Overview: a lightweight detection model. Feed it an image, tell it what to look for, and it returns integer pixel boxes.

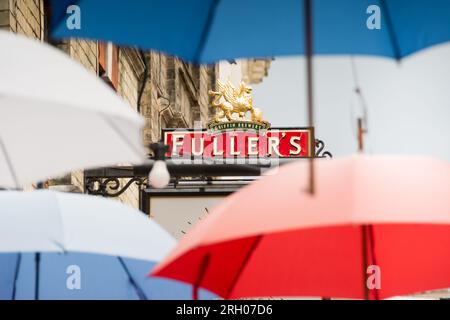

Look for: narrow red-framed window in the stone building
[98,42,119,90]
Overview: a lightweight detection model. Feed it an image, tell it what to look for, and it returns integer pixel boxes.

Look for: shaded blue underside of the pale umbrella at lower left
[0,252,214,300]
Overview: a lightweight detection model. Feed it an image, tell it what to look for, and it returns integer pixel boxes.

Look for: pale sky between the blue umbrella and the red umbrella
[253,45,450,161]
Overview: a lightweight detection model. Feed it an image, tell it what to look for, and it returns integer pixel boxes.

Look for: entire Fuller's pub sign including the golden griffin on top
[163,80,315,159]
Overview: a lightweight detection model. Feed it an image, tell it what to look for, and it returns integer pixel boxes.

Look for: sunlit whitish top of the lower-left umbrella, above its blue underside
[0,190,176,261]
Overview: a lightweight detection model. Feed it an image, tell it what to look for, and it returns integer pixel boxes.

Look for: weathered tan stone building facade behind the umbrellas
[0,0,267,207]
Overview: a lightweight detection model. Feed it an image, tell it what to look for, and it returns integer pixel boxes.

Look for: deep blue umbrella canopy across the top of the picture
[48,0,450,63]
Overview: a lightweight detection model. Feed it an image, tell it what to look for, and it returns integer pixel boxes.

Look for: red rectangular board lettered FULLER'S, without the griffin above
[163,126,314,158]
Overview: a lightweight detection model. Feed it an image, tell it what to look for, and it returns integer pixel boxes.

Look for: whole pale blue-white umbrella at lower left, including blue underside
[0,190,211,299]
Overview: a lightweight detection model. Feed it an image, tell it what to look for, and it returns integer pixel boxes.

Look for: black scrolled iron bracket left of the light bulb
[85,177,147,197]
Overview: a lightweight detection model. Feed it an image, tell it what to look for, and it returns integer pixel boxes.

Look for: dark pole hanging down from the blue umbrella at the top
[303,0,315,194]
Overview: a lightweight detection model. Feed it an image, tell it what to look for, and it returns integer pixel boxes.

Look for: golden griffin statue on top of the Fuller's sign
[208,80,270,127]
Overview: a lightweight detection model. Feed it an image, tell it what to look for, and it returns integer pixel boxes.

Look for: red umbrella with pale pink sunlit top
[152,155,450,299]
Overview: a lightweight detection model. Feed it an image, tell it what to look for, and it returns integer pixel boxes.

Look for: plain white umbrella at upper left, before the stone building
[0,31,145,188]
